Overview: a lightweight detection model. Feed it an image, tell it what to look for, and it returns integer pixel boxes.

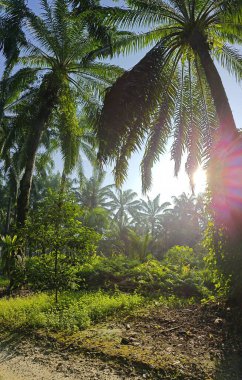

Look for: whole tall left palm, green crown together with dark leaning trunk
[0,0,121,225]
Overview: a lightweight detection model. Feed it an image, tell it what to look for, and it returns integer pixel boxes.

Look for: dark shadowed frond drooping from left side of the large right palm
[97,44,176,161]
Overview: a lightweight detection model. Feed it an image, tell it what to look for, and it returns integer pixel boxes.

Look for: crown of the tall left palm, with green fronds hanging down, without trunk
[12,0,122,171]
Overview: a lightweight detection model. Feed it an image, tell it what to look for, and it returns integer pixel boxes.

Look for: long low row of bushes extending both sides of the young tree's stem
[22,246,214,299]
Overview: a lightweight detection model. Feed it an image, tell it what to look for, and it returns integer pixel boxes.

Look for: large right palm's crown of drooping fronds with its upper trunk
[97,0,242,235]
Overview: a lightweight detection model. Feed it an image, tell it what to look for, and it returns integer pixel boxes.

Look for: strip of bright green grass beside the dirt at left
[0,291,144,331]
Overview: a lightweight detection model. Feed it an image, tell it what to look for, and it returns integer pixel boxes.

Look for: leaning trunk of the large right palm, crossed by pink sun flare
[195,36,242,305]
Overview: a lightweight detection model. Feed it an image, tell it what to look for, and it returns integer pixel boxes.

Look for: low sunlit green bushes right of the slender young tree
[73,246,214,298]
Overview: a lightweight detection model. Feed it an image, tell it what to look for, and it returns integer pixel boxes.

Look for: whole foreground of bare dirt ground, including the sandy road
[0,305,242,380]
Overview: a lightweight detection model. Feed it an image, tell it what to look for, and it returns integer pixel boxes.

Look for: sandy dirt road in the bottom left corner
[0,336,146,380]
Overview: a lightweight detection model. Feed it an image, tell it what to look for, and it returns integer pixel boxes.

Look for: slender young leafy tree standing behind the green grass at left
[21,191,100,301]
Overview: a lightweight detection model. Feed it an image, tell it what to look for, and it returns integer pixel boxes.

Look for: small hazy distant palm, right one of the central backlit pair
[139,194,170,238]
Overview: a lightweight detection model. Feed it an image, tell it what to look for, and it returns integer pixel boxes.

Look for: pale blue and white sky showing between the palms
[4,0,242,202]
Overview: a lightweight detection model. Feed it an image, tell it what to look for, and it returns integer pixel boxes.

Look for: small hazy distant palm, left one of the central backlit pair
[106,189,140,231]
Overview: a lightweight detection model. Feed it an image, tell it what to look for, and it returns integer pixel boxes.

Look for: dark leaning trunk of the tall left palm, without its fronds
[17,75,59,227]
